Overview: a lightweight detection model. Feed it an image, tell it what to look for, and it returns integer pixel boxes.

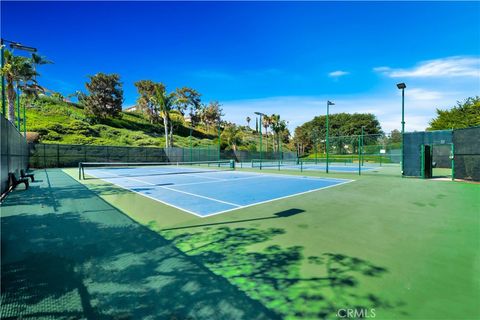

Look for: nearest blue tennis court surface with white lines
[85,168,353,217]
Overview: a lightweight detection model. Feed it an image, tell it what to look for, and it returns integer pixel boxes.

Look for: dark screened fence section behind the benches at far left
[0,115,28,194]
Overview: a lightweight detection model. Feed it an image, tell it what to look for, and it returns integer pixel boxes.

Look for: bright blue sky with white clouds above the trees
[1,1,480,132]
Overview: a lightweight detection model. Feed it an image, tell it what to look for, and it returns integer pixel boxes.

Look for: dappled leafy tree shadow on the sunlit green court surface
[162,226,403,319]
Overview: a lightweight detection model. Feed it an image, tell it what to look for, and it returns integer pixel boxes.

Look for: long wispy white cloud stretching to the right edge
[373,56,480,78]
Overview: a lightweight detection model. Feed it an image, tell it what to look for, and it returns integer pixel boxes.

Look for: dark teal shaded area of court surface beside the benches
[0,169,277,320]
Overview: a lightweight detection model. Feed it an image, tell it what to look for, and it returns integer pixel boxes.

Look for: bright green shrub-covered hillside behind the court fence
[23,97,216,147]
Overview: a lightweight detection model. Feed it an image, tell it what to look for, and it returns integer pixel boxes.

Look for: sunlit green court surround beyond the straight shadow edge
[66,169,480,319]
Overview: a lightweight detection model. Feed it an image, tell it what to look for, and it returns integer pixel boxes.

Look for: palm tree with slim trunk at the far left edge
[1,50,39,123]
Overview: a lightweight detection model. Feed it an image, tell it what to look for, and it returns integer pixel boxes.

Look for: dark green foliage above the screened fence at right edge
[427,96,480,130]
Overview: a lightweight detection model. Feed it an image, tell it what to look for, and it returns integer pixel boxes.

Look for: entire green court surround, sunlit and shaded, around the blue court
[1,169,480,319]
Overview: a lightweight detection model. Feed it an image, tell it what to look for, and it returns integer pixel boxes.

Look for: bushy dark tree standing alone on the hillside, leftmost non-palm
[82,73,123,121]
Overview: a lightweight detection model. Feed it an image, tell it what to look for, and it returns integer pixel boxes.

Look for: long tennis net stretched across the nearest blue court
[78,160,235,180]
